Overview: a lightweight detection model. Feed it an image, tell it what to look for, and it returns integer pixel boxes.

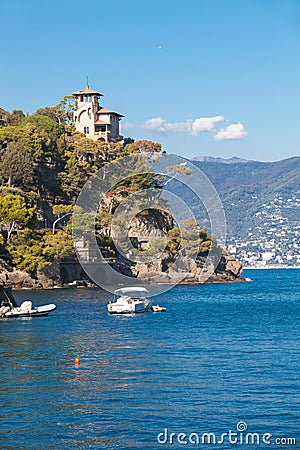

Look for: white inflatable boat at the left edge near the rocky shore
[0,285,56,318]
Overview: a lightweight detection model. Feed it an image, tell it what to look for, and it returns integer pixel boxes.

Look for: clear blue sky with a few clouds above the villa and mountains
[0,0,300,161]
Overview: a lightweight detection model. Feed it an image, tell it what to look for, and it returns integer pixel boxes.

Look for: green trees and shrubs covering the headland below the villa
[0,97,240,284]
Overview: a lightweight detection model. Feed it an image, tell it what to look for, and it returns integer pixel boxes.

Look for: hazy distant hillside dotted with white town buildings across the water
[193,157,300,265]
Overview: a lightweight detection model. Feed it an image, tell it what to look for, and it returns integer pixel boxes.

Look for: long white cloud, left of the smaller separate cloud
[142,116,225,136]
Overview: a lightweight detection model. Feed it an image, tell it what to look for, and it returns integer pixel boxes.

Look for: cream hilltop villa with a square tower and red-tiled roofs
[72,84,124,142]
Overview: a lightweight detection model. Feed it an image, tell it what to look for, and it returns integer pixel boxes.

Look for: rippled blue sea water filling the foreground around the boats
[0,269,300,450]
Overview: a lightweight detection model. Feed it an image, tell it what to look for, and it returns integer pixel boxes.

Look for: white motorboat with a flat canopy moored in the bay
[107,287,151,314]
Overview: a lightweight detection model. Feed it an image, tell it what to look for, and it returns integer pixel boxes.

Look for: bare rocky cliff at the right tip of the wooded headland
[97,196,242,283]
